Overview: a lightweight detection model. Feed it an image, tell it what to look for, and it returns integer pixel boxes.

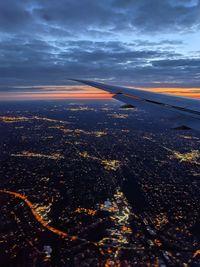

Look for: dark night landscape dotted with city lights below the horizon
[0,100,200,267]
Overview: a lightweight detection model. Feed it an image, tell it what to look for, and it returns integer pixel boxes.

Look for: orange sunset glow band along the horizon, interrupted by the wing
[0,85,200,101]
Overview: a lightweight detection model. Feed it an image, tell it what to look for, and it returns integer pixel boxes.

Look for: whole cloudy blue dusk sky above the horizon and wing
[0,0,200,99]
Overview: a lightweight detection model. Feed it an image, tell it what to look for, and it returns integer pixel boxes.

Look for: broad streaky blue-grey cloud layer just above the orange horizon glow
[0,39,199,87]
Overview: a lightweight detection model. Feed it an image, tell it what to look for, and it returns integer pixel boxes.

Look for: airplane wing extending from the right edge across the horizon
[73,80,200,131]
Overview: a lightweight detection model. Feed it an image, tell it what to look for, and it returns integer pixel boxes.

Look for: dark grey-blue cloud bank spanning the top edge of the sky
[0,0,200,32]
